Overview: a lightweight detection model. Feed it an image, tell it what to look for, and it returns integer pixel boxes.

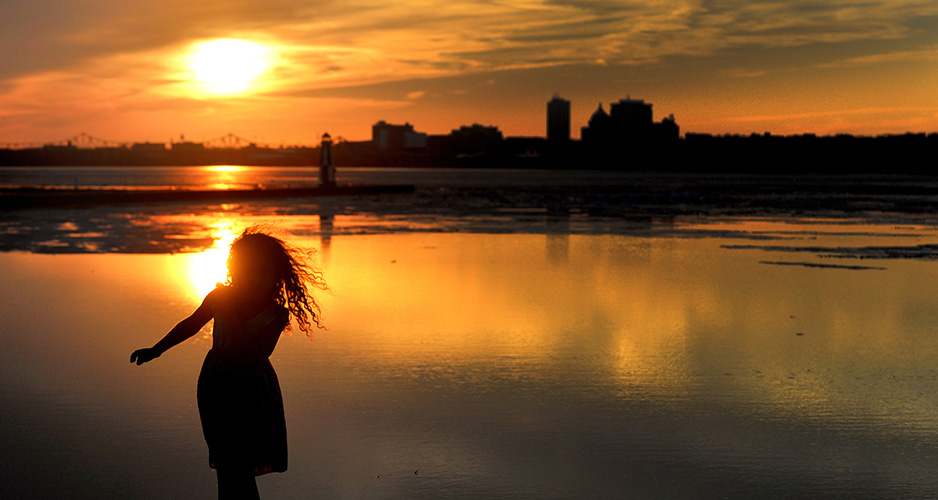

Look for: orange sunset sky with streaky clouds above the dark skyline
[0,0,938,147]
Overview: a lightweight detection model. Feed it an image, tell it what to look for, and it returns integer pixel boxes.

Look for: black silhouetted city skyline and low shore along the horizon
[0,94,938,173]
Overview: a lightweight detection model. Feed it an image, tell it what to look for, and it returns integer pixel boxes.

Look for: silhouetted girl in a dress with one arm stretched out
[130,228,326,500]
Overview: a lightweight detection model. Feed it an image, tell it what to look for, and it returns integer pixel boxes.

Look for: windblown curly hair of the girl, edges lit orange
[227,226,329,338]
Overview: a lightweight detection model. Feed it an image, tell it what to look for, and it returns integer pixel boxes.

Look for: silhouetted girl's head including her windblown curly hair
[228,227,327,334]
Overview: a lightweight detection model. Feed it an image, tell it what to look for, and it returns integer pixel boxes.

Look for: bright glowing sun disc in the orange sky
[189,38,275,95]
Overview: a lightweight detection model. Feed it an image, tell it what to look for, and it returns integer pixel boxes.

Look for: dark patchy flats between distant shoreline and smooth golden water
[0,171,938,259]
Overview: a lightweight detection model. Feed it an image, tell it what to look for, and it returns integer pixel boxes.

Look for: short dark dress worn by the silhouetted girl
[198,294,288,475]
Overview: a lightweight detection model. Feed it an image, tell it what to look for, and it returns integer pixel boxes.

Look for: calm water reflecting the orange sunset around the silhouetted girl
[0,169,938,499]
